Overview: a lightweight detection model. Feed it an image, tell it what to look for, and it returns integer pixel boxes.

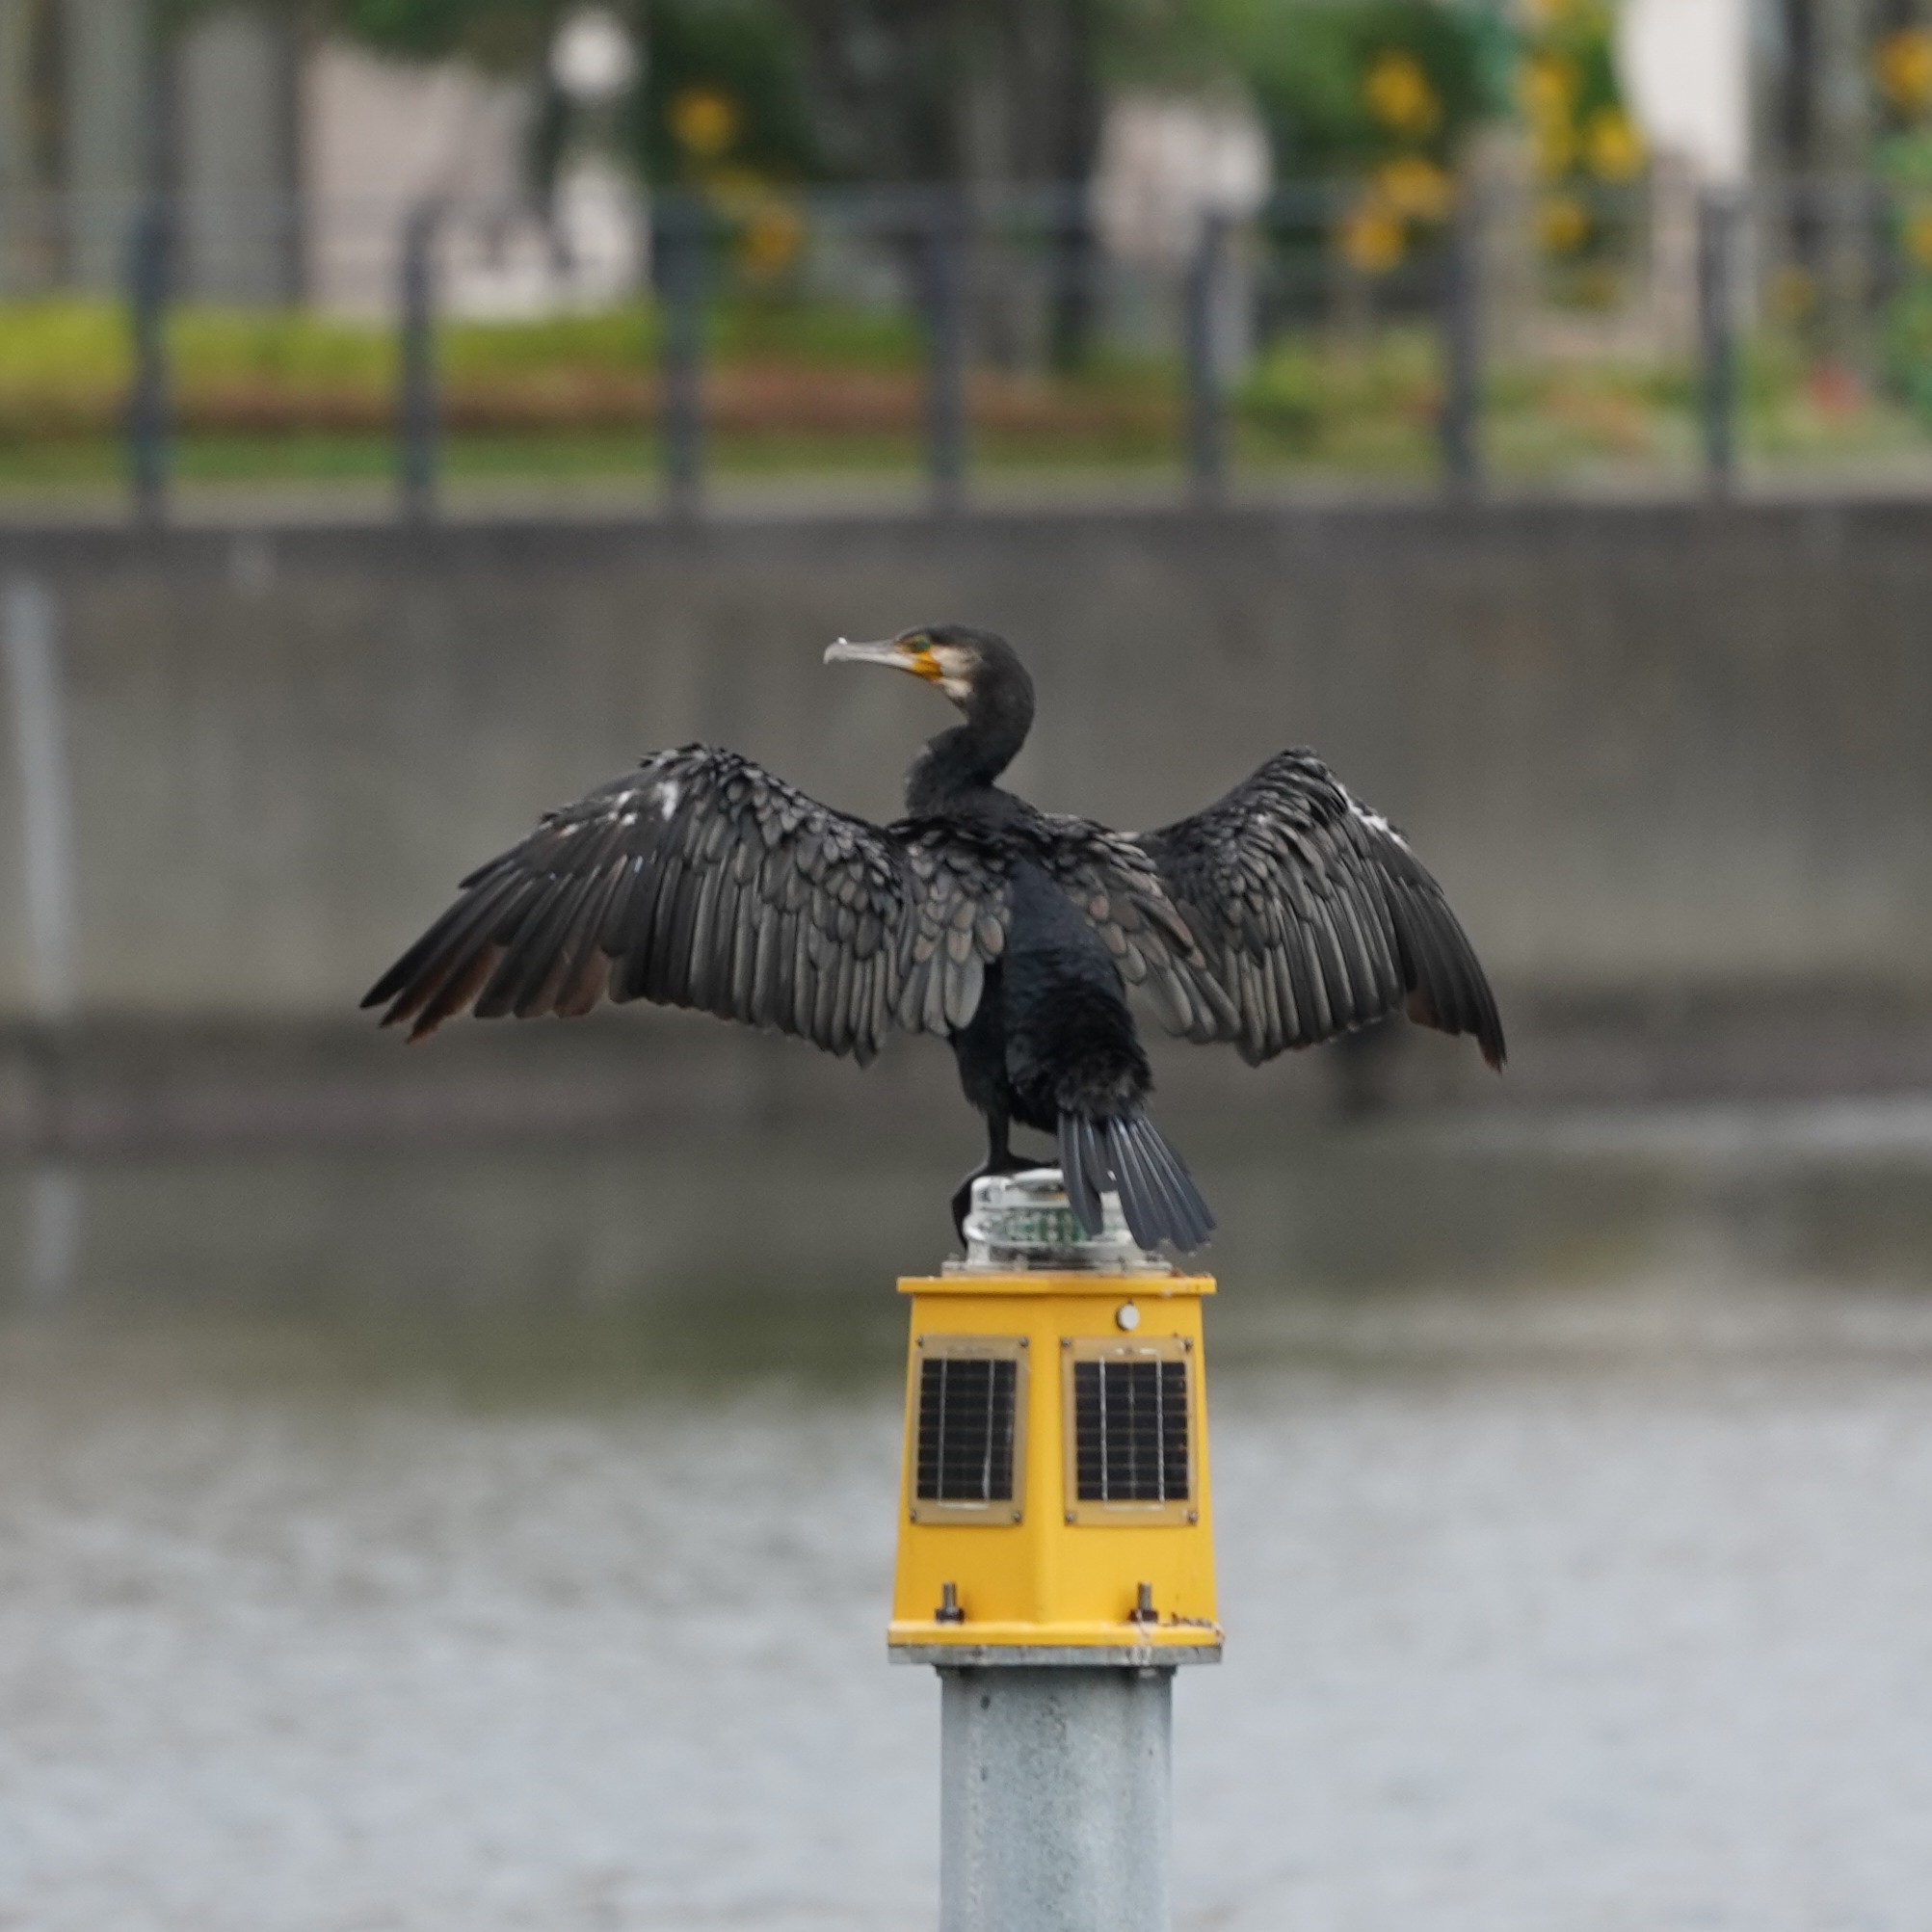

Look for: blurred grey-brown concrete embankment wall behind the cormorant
[0,506,1932,1017]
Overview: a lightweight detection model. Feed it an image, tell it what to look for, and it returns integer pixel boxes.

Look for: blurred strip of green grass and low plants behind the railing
[11,300,1932,498]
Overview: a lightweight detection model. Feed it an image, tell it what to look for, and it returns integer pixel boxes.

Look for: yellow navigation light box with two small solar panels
[887,1267,1221,1663]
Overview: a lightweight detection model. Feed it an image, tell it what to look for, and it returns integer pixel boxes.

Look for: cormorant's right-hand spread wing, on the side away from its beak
[1138,750,1503,1067]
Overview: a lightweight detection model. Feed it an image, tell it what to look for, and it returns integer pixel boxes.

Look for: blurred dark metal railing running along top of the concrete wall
[0,175,1932,521]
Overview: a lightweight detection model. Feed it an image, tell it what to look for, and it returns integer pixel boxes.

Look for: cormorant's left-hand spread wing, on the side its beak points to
[363,746,935,1061]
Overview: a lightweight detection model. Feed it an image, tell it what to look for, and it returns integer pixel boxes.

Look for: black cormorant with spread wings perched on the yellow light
[363,624,1503,1252]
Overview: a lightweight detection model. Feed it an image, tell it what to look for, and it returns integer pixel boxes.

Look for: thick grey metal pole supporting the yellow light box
[939,1663,1175,1932]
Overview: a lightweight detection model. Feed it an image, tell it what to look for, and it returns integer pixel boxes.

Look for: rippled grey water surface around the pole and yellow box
[0,1103,1932,1932]
